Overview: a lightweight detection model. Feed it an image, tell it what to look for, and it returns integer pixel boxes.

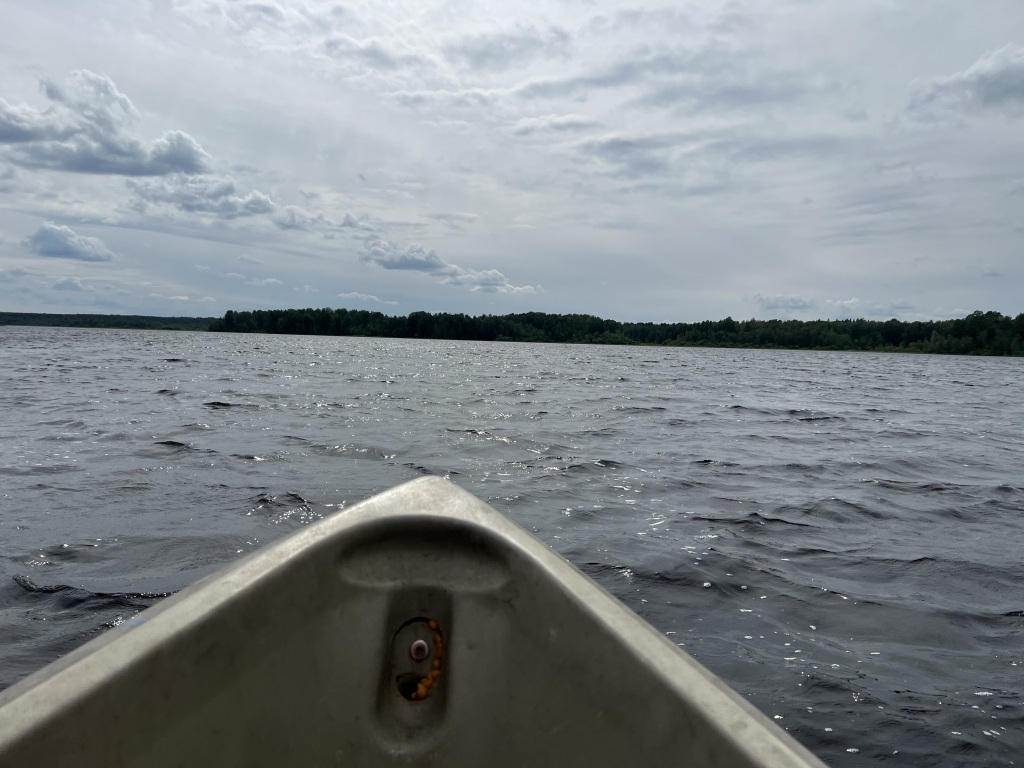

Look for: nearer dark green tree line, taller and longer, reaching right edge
[207,308,1024,355]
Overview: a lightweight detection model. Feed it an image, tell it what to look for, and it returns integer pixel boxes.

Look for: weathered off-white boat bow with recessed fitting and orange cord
[0,478,822,768]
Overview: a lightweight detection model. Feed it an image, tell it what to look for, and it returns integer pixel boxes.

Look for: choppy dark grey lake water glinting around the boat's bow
[0,328,1024,766]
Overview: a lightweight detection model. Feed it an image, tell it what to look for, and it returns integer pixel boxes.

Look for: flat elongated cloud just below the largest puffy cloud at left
[127,174,276,219]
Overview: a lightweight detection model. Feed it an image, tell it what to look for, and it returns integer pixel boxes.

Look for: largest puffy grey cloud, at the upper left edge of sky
[0,70,210,176]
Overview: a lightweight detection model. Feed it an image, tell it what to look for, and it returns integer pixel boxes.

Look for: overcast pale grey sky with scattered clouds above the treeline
[0,0,1024,323]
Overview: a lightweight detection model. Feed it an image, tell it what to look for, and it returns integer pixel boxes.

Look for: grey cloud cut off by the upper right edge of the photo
[908,45,1024,118]
